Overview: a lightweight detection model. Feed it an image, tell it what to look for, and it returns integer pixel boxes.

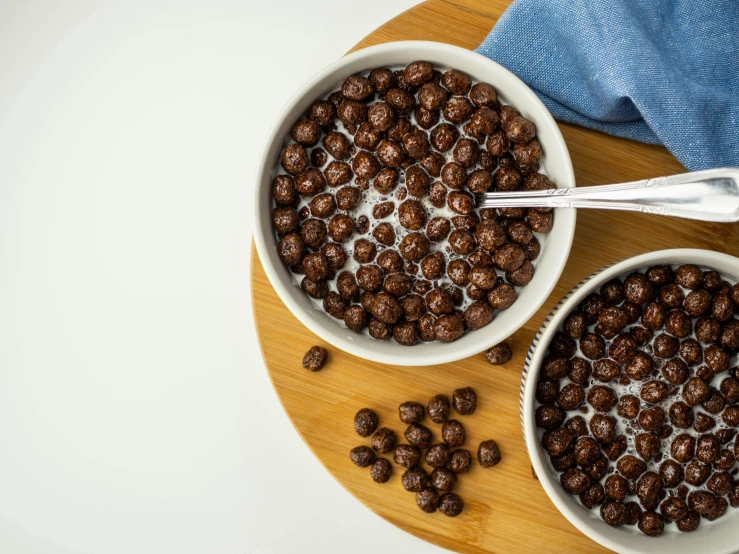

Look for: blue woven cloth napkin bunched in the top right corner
[477,0,739,170]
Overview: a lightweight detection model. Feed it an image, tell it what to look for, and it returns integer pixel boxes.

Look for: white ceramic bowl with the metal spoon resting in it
[254,41,575,366]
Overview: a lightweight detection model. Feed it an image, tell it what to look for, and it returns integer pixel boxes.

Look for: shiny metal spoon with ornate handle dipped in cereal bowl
[475,167,739,223]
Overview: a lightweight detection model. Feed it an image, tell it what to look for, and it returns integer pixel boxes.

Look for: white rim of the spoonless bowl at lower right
[521,248,739,554]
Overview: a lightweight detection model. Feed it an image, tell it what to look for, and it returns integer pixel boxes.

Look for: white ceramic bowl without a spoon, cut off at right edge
[520,249,739,554]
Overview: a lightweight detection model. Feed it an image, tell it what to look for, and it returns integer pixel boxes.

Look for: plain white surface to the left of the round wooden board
[0,0,472,554]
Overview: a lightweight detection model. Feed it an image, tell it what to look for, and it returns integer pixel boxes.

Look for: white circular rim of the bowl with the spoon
[252,40,577,366]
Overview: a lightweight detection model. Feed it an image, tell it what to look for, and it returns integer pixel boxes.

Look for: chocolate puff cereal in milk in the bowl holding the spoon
[271,60,556,342]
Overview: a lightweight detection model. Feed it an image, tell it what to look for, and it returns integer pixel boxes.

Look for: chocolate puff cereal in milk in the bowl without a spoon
[536,264,739,537]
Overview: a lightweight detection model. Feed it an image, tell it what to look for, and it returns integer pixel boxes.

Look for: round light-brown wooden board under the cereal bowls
[252,0,739,553]
